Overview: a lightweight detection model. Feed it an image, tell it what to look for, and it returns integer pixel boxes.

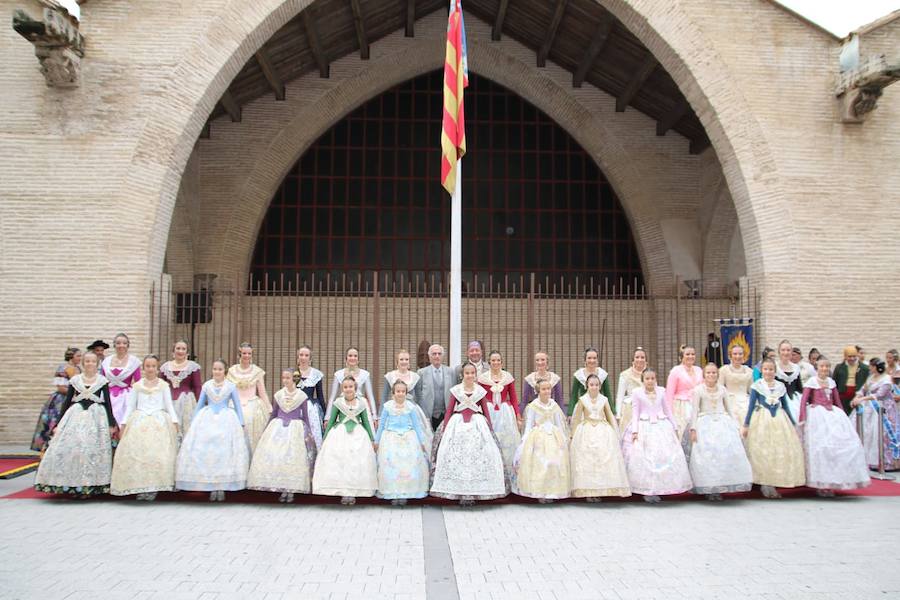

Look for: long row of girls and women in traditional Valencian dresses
[35,334,884,504]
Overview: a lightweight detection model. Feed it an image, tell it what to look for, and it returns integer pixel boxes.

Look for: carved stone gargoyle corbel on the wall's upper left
[13,0,84,87]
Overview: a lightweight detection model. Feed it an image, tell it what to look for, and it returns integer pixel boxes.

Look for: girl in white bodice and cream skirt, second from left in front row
[110,354,178,500]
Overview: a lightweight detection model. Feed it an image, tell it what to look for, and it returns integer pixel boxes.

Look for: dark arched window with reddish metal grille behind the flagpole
[252,72,643,289]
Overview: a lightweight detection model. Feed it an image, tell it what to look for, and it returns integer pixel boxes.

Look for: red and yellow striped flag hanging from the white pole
[441,0,469,196]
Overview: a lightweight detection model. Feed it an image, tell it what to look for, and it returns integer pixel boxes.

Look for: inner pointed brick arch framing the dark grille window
[198,15,697,290]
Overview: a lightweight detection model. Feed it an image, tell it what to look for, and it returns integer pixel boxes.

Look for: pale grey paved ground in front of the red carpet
[0,477,900,600]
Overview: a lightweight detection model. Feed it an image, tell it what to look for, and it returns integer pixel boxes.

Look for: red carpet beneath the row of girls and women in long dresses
[3,474,900,506]
